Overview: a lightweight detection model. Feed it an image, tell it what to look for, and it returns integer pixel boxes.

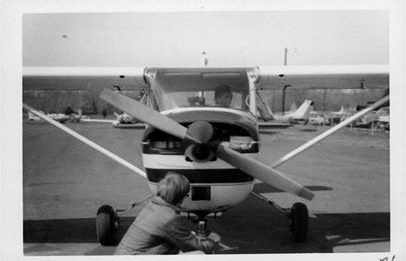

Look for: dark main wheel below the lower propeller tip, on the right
[290,202,309,242]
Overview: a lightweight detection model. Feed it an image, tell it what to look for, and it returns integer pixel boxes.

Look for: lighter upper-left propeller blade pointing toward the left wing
[100,89,201,143]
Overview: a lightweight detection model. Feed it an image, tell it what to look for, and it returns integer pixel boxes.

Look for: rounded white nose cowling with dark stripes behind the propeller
[142,107,259,212]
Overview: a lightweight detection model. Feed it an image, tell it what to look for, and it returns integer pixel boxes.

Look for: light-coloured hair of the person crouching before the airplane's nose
[157,172,190,205]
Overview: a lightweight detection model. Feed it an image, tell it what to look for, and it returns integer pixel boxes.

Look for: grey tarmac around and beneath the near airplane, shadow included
[23,121,391,256]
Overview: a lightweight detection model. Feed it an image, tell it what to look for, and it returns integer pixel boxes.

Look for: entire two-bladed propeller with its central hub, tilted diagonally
[101,89,314,200]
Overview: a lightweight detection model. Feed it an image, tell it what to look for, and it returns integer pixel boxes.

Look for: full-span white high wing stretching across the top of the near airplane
[23,65,389,92]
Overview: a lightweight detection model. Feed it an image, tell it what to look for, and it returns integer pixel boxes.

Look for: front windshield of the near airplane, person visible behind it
[149,69,249,111]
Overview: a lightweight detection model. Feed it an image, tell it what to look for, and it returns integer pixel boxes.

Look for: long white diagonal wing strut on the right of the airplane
[272,95,389,168]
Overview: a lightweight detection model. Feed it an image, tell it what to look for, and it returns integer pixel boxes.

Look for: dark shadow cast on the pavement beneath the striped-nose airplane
[24,197,390,255]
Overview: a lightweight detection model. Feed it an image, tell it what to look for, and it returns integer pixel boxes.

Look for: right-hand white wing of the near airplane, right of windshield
[258,65,389,89]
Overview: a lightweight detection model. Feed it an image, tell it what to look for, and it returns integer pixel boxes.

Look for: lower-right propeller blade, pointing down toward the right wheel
[217,145,314,200]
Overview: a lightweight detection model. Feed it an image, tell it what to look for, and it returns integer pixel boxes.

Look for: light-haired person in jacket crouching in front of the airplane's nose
[116,172,220,255]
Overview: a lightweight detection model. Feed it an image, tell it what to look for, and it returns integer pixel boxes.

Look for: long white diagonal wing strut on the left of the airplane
[23,103,147,178]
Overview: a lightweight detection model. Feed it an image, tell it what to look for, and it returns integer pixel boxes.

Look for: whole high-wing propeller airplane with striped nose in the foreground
[23,65,389,245]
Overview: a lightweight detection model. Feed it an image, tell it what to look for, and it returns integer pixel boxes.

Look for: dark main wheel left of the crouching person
[96,205,118,246]
